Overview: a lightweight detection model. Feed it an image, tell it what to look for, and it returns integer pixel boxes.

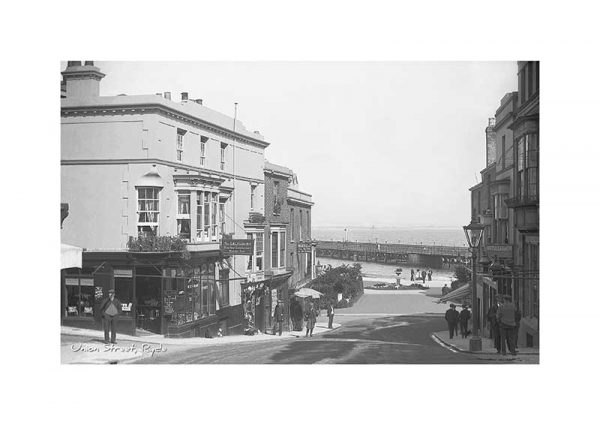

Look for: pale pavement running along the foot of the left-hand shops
[61,317,341,364]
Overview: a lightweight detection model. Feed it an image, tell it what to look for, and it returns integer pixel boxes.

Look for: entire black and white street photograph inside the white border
[60,60,541,364]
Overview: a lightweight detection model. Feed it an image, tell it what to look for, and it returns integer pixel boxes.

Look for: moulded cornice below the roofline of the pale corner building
[60,103,269,148]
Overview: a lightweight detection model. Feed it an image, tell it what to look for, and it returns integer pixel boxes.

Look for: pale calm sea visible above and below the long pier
[312,226,466,288]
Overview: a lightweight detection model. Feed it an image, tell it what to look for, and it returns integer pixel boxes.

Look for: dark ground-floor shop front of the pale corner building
[61,251,241,337]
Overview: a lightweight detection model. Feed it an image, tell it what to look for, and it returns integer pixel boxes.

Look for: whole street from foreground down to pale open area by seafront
[130,288,506,364]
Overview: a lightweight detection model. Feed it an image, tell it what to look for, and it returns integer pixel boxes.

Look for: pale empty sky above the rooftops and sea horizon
[79,61,517,227]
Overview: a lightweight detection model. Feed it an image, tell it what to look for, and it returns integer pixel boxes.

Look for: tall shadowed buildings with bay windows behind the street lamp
[469,62,539,346]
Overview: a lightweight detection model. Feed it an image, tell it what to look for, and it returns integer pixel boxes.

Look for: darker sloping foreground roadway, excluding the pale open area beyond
[138,316,483,364]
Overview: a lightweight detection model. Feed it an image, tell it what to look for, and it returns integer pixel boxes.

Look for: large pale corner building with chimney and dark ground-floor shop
[61,61,268,336]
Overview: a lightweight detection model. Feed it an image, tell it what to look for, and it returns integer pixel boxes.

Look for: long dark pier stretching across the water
[316,241,469,269]
